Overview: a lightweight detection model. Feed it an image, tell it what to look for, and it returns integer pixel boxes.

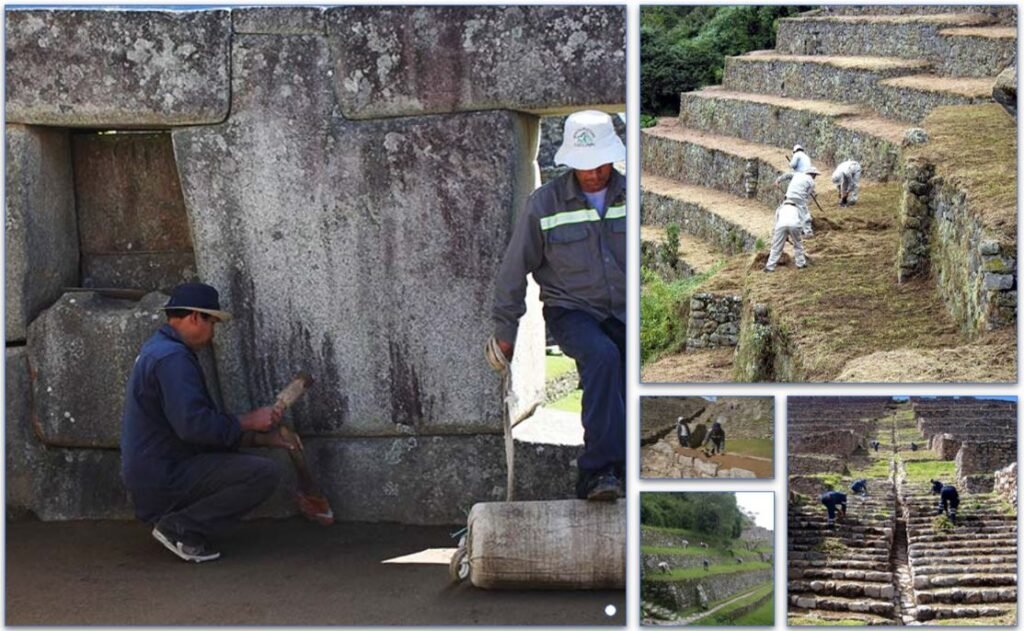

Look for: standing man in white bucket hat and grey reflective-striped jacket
[487,111,626,501]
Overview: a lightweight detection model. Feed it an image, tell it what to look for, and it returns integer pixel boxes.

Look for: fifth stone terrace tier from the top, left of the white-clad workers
[640,173,774,254]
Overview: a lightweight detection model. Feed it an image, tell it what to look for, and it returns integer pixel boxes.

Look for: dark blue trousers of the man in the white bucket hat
[544,307,626,476]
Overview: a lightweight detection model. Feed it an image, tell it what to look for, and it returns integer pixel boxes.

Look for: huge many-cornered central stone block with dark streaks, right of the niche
[174,33,543,435]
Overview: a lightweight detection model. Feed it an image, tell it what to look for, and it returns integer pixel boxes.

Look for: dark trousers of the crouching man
[132,453,282,545]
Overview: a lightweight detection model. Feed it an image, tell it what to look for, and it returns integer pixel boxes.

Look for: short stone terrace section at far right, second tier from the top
[869,74,995,124]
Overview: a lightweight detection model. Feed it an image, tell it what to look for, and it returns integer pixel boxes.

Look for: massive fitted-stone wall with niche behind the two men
[5,6,626,523]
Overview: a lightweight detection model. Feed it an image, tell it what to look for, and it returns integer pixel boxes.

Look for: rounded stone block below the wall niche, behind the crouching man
[29,292,167,448]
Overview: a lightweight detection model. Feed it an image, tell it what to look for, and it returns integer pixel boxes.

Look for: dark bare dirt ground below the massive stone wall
[4,518,626,627]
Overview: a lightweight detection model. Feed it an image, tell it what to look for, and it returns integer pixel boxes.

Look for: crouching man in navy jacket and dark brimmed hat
[121,283,295,562]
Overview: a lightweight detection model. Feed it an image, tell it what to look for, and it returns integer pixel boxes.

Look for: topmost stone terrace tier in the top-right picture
[775,13,1016,77]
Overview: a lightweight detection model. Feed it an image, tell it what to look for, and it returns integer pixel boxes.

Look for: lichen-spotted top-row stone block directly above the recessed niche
[5,9,231,127]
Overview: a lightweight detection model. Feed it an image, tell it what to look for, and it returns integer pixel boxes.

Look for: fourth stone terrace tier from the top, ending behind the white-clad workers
[640,118,802,208]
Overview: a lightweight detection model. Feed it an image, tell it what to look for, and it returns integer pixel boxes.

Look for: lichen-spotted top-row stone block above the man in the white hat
[327,5,626,119]
